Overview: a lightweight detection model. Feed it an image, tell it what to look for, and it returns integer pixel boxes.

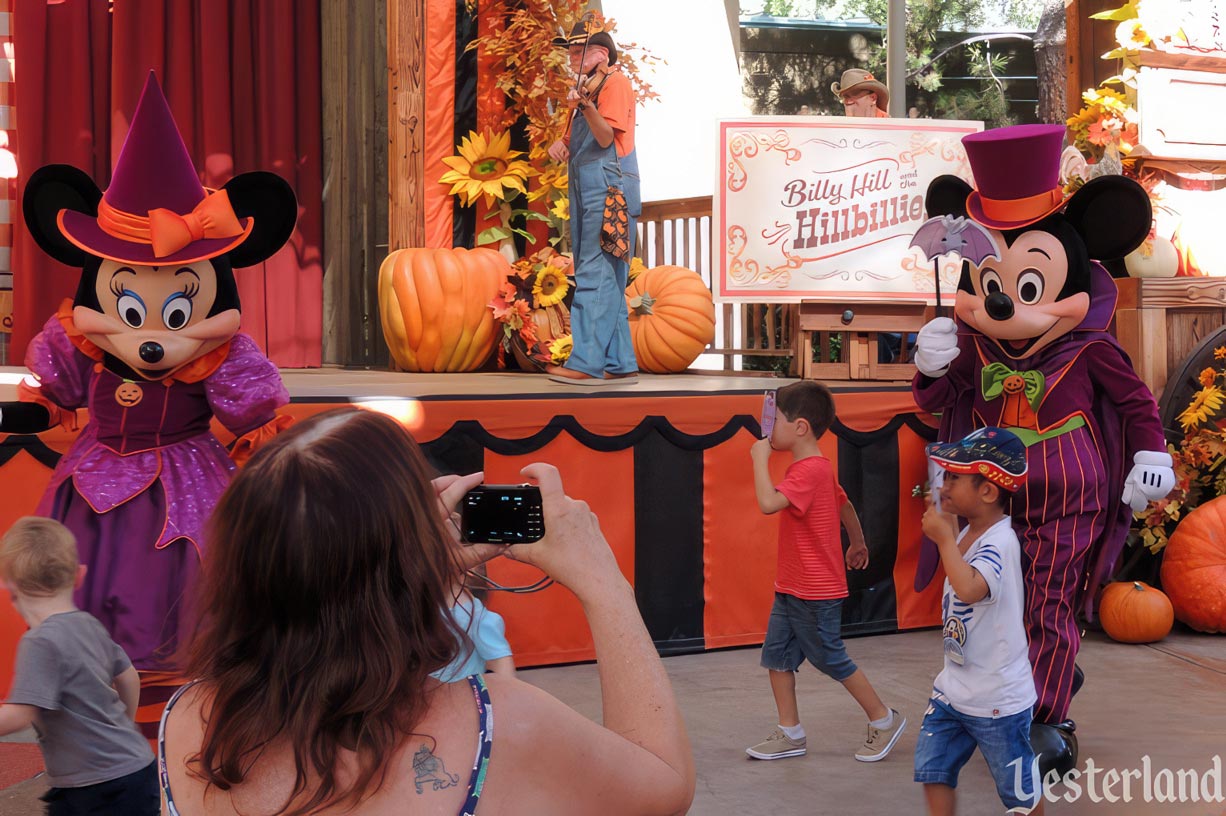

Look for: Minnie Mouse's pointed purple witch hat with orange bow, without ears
[56,71,255,265]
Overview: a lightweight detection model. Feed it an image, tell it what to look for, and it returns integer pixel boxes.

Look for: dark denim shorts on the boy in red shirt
[761,592,856,682]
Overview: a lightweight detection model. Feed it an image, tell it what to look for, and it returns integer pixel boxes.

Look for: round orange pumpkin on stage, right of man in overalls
[625,266,715,374]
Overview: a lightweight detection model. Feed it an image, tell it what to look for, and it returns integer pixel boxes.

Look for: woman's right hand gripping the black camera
[506,462,624,600]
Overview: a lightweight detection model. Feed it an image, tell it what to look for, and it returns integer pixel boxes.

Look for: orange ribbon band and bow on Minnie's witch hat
[98,190,244,257]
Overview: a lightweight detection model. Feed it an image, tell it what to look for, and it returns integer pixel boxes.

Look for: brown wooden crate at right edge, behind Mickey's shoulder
[1114,278,1226,395]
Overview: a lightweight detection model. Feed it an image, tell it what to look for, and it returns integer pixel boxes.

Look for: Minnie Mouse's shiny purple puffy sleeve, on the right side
[205,334,289,436]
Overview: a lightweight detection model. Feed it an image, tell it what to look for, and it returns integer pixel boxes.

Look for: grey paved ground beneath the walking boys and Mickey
[0,631,1226,816]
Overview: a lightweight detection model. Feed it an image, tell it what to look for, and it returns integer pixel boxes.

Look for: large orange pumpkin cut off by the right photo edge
[1162,496,1226,632]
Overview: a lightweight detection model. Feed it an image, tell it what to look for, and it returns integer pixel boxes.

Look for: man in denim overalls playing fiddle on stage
[546,22,642,386]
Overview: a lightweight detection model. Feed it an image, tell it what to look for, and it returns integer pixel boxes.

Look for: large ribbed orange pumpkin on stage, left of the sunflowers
[379,241,511,371]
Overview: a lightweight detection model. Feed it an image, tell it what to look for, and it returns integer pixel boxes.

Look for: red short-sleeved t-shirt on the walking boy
[775,456,847,600]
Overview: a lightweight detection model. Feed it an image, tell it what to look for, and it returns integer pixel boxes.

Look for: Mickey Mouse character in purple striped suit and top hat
[912,125,1175,762]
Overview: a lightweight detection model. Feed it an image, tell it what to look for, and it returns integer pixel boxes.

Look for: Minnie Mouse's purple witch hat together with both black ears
[23,71,298,266]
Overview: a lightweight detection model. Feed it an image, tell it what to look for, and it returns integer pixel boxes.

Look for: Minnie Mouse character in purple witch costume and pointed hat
[0,74,297,670]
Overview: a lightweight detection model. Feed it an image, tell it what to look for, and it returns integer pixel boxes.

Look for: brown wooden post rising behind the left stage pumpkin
[387,0,425,251]
